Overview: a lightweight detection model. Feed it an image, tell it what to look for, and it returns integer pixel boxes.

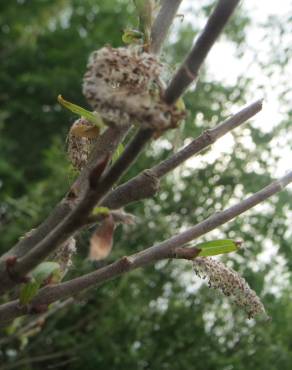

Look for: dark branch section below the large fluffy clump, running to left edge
[0,129,153,293]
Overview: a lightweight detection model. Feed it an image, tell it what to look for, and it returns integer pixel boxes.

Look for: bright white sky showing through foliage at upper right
[179,0,292,176]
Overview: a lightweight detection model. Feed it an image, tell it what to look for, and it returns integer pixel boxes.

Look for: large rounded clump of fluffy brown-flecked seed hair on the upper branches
[83,46,185,131]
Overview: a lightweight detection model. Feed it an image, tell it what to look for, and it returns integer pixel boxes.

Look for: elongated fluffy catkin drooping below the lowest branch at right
[193,257,267,318]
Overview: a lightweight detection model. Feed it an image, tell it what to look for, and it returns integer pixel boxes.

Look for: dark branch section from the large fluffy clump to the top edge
[164,0,240,104]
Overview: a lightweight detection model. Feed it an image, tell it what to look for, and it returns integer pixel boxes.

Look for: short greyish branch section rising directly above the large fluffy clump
[150,0,182,54]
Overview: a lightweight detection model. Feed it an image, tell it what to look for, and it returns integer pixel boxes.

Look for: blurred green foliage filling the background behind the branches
[0,0,292,370]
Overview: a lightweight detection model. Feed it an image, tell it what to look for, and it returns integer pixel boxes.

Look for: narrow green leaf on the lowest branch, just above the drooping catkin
[196,239,240,257]
